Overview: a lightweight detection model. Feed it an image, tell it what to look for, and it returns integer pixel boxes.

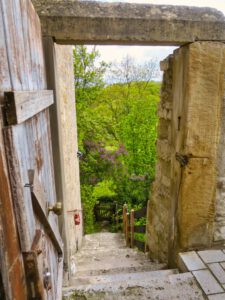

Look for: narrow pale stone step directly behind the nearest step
[70,269,179,289]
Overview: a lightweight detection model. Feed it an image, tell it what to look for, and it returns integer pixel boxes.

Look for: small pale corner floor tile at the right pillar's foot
[179,251,207,271]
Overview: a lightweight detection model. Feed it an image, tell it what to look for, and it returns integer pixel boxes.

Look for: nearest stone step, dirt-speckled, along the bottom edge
[63,273,204,300]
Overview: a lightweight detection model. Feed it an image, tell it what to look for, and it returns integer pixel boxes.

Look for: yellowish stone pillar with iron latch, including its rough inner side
[148,42,225,262]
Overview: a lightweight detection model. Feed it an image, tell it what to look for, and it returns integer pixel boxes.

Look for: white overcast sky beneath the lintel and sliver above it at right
[87,0,225,79]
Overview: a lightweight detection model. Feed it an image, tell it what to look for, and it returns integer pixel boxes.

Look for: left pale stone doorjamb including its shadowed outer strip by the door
[44,38,83,276]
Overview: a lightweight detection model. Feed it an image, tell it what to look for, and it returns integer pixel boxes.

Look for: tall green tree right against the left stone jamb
[73,45,107,232]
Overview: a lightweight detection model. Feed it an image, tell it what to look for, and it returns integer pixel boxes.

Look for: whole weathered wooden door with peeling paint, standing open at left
[0,0,63,300]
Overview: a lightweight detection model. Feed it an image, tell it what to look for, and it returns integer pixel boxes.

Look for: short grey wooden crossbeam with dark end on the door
[4,90,54,125]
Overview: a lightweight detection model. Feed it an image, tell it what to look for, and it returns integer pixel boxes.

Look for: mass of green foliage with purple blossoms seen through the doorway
[74,46,160,232]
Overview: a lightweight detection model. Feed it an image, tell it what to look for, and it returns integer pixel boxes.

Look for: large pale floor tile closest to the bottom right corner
[192,270,224,295]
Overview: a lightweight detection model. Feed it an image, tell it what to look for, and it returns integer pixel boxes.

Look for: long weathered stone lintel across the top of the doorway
[33,0,225,45]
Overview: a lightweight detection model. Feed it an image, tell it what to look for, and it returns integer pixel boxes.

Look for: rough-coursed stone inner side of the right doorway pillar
[147,56,173,261]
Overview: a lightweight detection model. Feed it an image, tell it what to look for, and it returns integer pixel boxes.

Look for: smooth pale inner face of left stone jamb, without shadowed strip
[55,44,83,256]
